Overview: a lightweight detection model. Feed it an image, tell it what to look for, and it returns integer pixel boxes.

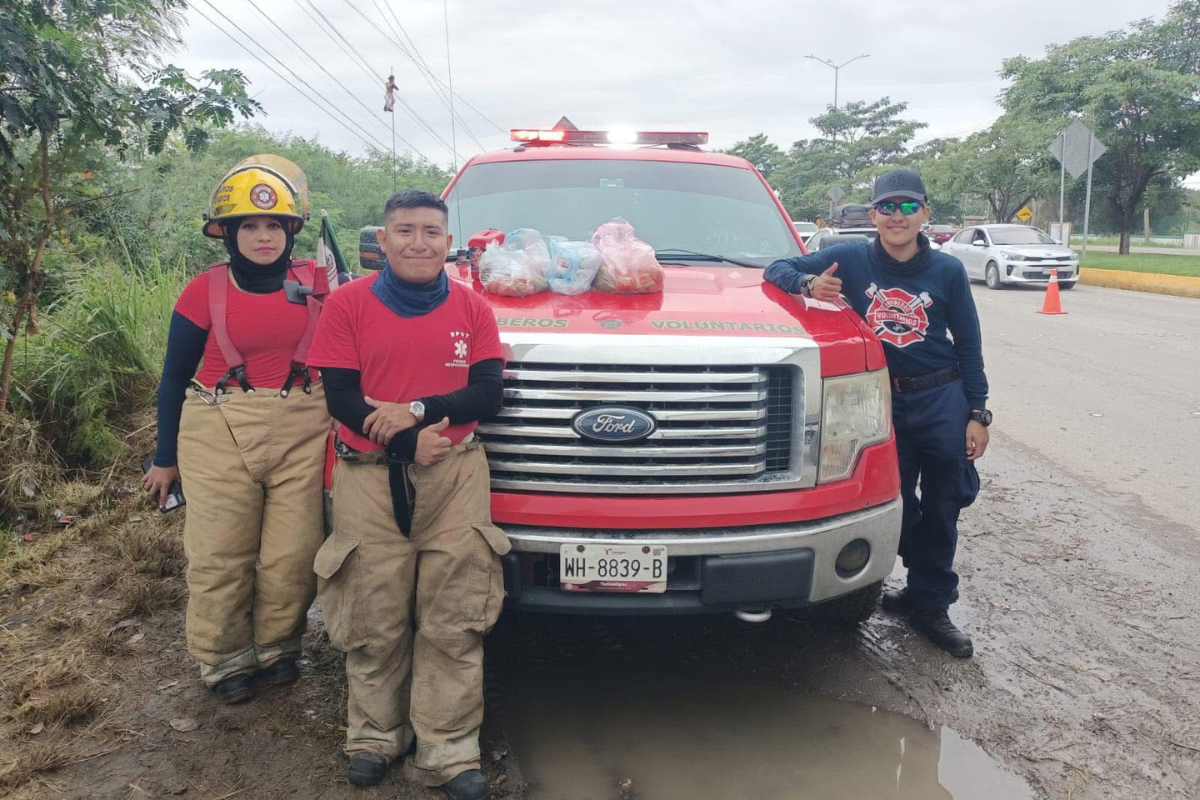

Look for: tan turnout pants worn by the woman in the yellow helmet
[179,384,330,686]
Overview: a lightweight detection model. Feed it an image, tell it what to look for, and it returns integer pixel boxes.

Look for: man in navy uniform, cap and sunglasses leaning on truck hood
[766,169,991,658]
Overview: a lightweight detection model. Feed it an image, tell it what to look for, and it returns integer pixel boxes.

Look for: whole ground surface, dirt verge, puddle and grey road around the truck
[0,287,1200,800]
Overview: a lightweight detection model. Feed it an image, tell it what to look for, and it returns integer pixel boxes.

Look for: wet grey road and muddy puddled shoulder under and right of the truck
[487,287,1200,800]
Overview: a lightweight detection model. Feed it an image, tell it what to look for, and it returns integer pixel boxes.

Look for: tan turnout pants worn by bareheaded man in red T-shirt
[316,441,511,786]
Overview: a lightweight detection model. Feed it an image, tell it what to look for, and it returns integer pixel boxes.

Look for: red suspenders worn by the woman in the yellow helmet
[209,261,329,397]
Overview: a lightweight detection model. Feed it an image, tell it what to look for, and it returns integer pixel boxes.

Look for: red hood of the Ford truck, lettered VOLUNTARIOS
[448,265,877,375]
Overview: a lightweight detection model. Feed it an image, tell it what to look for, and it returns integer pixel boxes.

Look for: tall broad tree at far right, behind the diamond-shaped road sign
[1001,0,1200,254]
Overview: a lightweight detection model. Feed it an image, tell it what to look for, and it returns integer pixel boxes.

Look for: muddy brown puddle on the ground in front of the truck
[505,670,1033,800]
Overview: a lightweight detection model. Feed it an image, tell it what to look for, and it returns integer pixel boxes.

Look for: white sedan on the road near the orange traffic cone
[942,225,1079,289]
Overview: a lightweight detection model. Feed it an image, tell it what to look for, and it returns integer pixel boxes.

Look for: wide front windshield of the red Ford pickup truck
[446,160,800,266]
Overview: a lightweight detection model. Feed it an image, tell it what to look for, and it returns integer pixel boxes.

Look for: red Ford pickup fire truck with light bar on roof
[410,130,901,622]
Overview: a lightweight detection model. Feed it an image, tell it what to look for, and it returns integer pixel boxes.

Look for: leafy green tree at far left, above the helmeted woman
[0,0,260,413]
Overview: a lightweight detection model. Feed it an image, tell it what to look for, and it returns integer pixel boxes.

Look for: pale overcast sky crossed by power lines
[170,0,1170,166]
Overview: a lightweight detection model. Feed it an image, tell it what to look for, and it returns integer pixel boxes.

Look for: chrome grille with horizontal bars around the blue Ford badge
[476,362,803,494]
